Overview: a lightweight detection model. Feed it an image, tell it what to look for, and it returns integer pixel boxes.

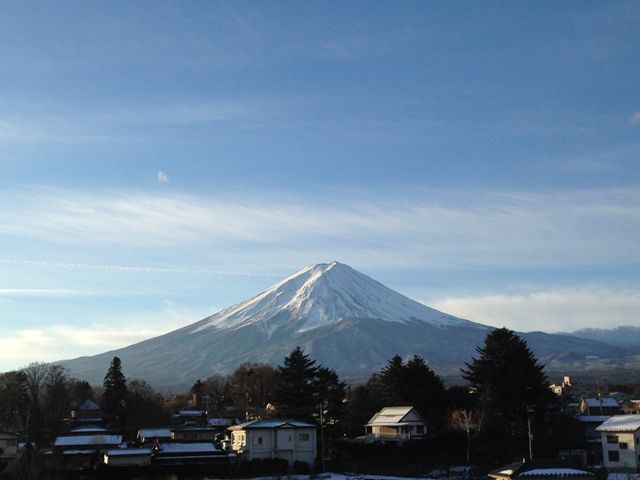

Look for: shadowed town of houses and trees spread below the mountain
[0,328,640,480]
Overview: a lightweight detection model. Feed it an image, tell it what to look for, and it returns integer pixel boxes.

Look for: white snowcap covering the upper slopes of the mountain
[192,262,480,336]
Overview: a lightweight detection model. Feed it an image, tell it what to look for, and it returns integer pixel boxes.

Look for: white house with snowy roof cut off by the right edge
[596,415,640,472]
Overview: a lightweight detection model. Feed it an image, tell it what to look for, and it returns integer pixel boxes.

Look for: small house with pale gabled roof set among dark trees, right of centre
[364,407,427,442]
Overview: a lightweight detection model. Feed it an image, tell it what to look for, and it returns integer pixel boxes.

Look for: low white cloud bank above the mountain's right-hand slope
[432,287,640,332]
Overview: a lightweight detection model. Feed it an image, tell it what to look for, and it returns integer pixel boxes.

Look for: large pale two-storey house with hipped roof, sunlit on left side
[229,419,316,465]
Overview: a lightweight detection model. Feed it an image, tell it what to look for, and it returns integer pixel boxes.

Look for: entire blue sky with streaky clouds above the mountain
[0,1,640,370]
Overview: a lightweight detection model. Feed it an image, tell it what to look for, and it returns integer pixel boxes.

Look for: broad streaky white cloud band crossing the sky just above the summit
[0,187,640,272]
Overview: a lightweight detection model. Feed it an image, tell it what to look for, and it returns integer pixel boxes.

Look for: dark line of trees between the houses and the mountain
[0,329,553,462]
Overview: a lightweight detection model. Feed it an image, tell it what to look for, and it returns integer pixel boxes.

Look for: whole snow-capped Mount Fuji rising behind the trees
[58,262,632,387]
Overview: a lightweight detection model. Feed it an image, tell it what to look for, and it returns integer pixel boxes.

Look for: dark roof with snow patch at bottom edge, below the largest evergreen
[489,460,595,480]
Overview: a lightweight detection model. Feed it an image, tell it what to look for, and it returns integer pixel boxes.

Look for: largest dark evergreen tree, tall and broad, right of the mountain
[462,328,552,460]
